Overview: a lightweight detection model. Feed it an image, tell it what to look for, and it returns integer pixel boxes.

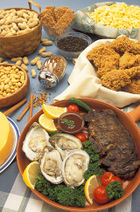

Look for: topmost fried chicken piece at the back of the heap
[110,36,136,54]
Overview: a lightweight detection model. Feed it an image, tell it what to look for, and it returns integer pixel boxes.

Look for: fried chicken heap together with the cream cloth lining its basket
[55,35,140,108]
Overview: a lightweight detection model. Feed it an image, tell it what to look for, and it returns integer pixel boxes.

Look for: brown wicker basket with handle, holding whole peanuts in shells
[0,0,42,58]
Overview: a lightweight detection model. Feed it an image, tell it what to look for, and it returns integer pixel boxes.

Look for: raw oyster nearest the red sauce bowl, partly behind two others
[49,133,82,159]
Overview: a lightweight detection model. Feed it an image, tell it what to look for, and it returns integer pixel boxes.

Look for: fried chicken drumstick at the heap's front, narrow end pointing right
[101,66,140,91]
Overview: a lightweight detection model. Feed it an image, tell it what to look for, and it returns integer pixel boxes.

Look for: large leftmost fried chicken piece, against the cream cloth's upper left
[87,44,120,77]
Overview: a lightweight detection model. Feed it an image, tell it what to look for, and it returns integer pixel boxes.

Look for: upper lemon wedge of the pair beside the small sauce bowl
[42,104,67,119]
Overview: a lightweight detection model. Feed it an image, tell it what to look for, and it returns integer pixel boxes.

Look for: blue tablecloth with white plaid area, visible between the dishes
[0,0,140,212]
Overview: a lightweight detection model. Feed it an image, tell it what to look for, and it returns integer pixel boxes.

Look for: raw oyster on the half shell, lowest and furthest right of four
[62,150,90,187]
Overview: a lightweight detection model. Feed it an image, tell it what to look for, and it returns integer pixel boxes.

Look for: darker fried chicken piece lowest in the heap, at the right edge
[123,79,140,94]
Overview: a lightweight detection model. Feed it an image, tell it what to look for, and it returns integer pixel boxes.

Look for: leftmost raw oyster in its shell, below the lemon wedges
[22,122,53,161]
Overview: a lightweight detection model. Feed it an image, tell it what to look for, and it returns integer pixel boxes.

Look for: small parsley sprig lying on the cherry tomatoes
[106,180,124,199]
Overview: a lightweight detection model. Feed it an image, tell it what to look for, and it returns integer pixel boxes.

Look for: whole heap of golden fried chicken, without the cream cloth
[87,36,140,94]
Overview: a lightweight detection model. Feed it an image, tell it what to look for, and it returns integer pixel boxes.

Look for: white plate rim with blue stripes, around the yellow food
[0,116,20,173]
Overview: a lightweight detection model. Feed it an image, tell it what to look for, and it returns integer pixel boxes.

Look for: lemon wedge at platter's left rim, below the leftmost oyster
[22,161,40,189]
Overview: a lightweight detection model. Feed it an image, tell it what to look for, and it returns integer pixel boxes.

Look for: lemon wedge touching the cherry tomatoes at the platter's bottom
[84,175,99,205]
